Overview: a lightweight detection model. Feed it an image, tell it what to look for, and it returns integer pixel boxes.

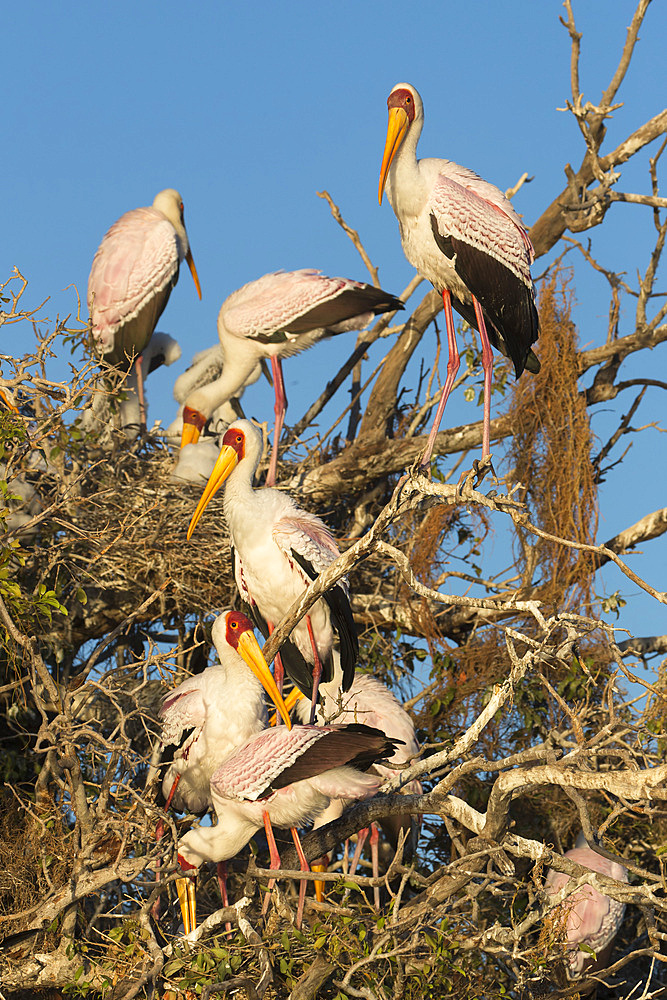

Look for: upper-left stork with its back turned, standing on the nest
[88,188,201,423]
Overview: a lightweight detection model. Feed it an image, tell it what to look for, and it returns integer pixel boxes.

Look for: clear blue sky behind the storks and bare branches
[0,0,667,664]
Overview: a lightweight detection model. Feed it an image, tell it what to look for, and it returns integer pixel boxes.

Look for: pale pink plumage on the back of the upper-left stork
[88,208,184,352]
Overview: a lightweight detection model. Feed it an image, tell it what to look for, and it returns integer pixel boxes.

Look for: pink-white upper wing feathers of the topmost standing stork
[429,174,534,288]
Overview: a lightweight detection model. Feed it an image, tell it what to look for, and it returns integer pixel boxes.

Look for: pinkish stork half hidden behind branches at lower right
[544,833,628,979]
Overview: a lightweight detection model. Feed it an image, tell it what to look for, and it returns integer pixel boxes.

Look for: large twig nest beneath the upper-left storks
[18,437,240,645]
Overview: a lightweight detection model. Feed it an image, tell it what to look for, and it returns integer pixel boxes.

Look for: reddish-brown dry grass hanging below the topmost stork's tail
[510,269,598,609]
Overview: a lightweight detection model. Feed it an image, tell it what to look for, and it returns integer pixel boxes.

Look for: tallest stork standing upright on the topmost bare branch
[379,83,539,465]
